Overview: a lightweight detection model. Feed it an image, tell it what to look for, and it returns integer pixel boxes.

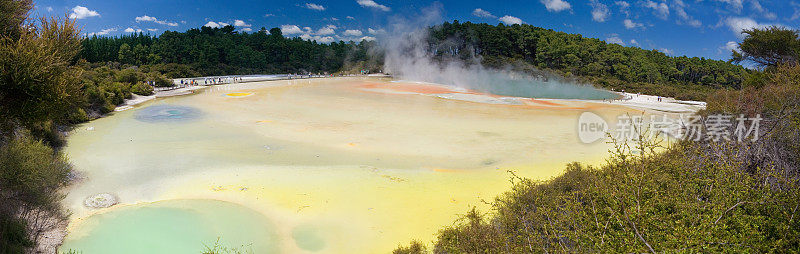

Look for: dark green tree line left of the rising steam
[80,26,377,77]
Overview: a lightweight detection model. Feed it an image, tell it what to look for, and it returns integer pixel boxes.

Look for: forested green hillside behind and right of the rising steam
[428,20,749,100]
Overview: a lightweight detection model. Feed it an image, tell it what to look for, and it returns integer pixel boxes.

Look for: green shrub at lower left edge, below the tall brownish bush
[0,134,72,253]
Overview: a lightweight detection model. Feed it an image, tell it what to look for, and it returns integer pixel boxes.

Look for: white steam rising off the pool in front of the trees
[380,5,616,100]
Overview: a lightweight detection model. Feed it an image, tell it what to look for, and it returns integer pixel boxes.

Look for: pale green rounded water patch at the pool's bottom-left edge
[61,199,280,254]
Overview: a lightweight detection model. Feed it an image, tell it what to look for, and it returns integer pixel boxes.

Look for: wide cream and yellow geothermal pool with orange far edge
[61,78,641,254]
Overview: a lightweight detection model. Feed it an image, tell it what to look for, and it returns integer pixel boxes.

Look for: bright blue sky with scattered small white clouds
[34,0,800,60]
